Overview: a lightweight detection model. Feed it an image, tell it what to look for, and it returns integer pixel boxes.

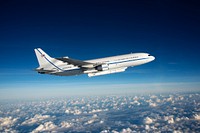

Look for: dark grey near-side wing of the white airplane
[56,57,97,68]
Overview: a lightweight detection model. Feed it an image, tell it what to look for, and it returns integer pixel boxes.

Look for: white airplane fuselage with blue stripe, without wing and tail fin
[49,53,155,76]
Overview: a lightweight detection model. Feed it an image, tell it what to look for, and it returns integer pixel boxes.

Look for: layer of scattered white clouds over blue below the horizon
[0,93,200,133]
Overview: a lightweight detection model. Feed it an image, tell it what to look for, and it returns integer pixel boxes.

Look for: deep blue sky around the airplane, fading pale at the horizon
[0,0,200,98]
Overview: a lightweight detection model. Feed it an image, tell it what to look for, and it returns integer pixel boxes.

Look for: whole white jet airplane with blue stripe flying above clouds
[34,48,155,77]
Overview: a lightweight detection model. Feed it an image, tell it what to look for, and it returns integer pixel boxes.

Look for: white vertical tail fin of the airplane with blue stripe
[34,48,53,68]
